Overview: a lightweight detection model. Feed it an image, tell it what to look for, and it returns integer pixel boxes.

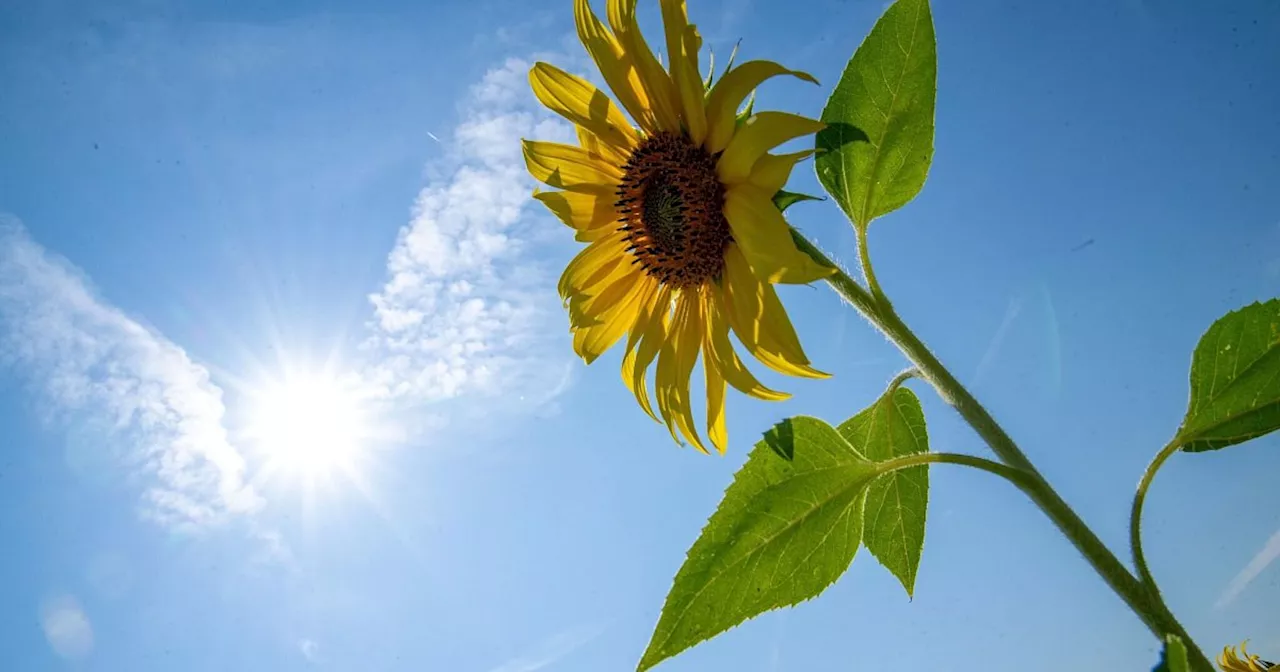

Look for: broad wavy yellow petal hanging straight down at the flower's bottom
[655,292,707,453]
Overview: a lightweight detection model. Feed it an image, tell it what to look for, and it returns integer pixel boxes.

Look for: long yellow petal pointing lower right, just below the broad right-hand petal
[723,246,831,378]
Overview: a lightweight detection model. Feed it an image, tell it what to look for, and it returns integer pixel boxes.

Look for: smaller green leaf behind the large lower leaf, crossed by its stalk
[840,387,929,595]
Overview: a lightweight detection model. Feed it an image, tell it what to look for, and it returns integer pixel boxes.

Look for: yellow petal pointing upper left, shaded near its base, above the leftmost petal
[529,63,637,150]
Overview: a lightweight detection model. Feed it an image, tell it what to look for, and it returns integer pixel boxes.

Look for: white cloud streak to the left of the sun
[0,219,261,529]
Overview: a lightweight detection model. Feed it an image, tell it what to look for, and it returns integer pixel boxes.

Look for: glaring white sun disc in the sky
[247,374,370,479]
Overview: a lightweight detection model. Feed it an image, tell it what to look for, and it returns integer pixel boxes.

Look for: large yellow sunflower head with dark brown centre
[524,0,835,453]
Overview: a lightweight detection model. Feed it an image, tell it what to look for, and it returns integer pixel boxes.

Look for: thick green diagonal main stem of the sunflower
[792,227,1213,672]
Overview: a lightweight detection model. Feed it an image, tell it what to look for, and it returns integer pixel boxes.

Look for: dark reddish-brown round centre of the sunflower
[616,133,732,288]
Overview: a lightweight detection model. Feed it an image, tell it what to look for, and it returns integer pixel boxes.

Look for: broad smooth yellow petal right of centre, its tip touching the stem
[724,184,836,284]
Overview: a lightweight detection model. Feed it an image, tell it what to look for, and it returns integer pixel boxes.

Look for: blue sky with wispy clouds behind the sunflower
[0,0,1280,672]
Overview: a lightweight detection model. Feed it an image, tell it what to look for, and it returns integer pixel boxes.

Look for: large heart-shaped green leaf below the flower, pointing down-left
[639,417,877,671]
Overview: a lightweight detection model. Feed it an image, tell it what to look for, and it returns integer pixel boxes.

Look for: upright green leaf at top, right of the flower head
[814,0,938,228]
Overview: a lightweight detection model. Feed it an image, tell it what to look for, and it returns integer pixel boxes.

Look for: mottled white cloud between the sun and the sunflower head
[364,59,570,402]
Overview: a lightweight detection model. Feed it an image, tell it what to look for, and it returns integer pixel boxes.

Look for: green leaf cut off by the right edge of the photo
[1176,298,1280,452]
